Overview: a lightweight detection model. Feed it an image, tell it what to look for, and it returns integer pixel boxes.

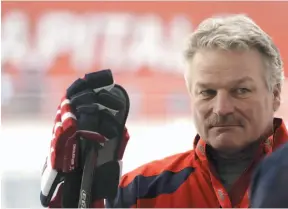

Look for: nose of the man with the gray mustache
[214,91,234,115]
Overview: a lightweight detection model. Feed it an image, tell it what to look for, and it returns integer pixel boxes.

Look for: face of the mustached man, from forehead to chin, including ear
[189,50,279,152]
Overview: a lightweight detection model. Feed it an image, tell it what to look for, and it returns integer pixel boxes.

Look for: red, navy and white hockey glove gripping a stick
[41,70,129,207]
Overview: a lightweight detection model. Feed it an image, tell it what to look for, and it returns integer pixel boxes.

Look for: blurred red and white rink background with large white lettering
[1,1,288,208]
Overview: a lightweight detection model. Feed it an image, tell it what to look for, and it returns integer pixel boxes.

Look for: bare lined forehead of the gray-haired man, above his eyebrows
[189,51,265,87]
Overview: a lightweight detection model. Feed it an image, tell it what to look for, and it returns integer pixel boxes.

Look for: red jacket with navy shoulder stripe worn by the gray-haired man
[50,119,288,208]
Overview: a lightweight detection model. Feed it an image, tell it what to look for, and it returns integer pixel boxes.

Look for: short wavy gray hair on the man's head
[184,14,284,91]
